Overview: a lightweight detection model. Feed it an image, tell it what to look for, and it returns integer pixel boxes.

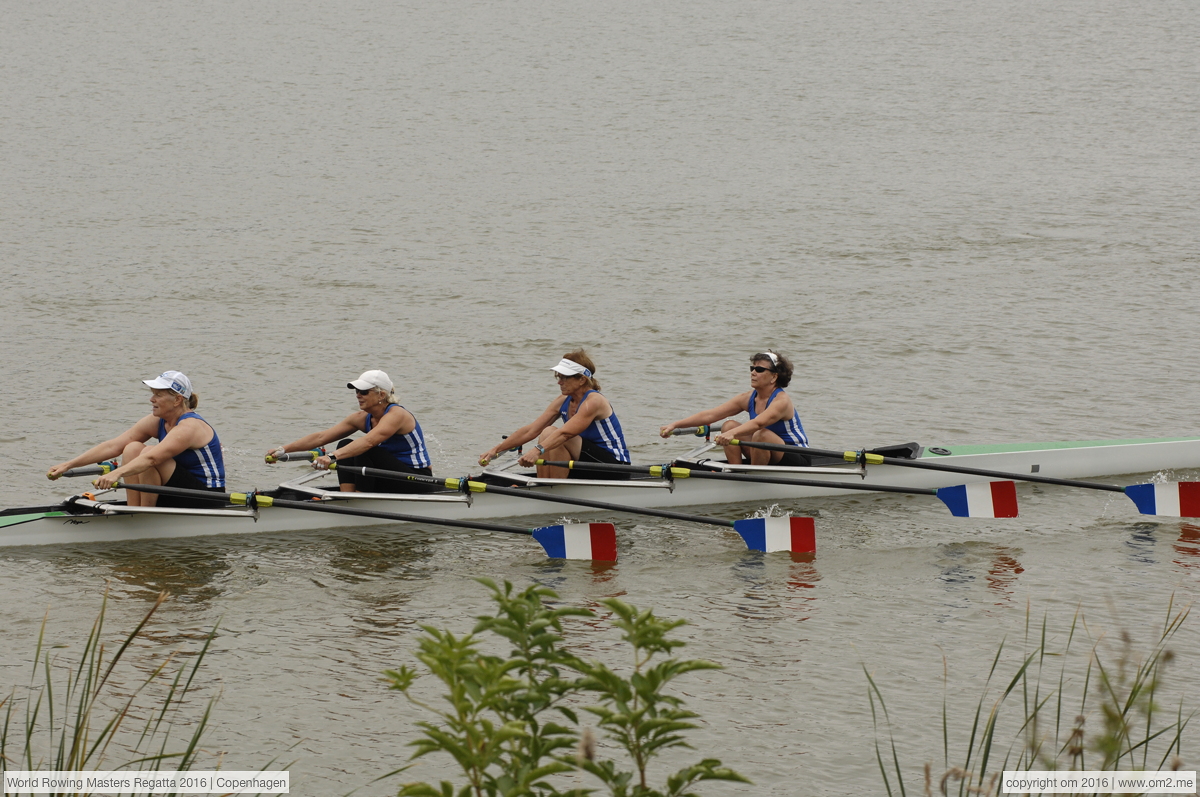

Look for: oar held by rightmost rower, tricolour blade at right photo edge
[730,441,1200,517]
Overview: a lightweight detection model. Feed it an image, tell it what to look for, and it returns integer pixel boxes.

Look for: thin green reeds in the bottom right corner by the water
[863,597,1195,797]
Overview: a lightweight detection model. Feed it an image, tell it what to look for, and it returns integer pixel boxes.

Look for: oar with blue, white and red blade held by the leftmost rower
[98,483,617,562]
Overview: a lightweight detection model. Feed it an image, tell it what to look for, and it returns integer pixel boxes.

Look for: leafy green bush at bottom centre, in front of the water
[385,579,749,797]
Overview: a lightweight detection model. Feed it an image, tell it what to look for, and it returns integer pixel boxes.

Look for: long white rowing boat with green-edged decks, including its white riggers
[0,437,1200,546]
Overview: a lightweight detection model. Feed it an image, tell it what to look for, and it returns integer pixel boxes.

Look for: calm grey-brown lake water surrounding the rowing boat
[0,0,1200,795]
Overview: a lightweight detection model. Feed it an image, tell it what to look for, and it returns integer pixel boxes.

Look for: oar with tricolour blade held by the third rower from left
[538,460,1018,517]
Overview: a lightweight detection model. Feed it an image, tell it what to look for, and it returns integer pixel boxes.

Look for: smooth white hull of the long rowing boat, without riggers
[0,438,1200,546]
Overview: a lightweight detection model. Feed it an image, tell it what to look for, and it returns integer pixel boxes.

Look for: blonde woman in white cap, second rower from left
[266,371,433,492]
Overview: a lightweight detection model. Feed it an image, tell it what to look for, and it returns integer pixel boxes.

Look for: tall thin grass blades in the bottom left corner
[0,593,216,793]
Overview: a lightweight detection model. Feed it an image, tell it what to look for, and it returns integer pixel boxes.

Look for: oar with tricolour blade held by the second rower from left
[334,462,816,552]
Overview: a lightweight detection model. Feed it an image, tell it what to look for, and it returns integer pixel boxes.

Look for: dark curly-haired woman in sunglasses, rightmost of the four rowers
[659,349,810,466]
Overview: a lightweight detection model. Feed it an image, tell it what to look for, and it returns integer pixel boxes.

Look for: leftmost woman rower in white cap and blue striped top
[46,371,224,508]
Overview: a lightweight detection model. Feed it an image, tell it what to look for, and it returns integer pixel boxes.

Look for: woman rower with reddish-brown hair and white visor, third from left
[479,349,629,479]
